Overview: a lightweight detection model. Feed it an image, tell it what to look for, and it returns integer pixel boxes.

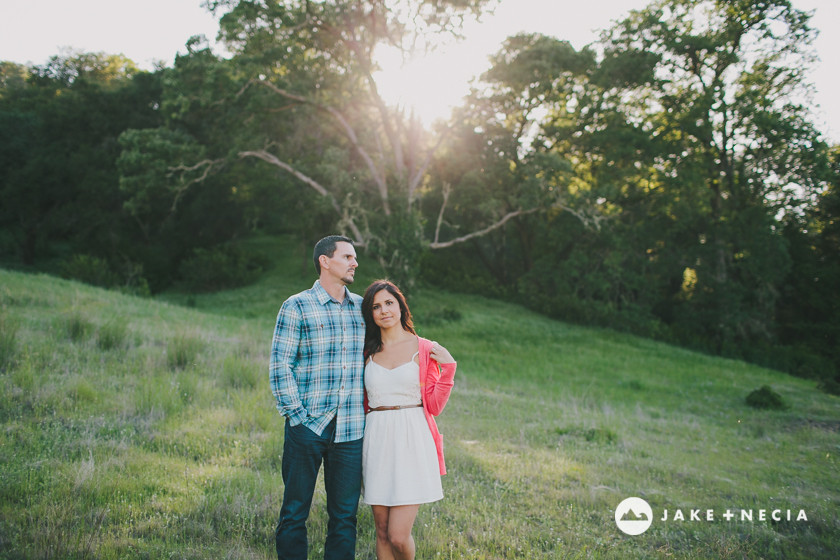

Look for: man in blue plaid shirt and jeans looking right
[269,235,365,560]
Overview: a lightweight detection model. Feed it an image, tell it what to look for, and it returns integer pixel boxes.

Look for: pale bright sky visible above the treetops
[0,0,840,141]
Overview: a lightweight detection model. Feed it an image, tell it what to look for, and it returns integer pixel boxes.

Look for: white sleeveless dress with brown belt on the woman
[362,354,443,506]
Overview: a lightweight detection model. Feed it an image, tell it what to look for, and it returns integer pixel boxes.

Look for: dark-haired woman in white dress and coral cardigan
[362,280,456,560]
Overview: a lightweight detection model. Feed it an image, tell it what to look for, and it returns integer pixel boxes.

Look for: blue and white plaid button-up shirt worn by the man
[269,280,365,443]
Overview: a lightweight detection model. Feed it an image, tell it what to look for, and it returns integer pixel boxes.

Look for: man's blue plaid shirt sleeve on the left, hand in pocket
[269,300,308,426]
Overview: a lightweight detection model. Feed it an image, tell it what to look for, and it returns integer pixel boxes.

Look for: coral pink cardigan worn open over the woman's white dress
[365,336,457,475]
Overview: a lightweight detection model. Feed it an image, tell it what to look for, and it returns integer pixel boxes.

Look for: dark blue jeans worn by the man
[275,419,362,560]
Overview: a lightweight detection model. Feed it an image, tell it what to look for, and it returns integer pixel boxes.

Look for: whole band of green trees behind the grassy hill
[0,0,840,392]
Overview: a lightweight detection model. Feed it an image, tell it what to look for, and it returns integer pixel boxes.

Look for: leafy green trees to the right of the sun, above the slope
[424,0,840,379]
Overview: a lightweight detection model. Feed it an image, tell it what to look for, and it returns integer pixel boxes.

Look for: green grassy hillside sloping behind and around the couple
[0,242,840,559]
